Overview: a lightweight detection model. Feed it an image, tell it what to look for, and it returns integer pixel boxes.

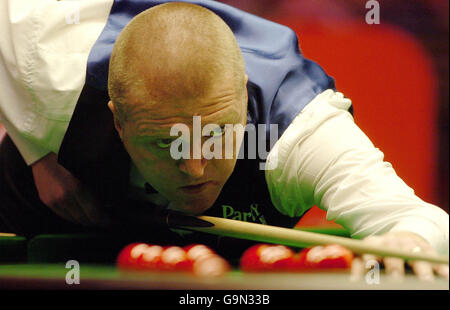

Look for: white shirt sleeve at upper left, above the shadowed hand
[0,0,113,164]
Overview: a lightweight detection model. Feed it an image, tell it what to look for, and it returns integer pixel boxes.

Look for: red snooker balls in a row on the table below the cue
[117,243,353,277]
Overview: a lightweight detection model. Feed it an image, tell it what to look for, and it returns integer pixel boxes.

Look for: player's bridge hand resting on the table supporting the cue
[352,232,449,281]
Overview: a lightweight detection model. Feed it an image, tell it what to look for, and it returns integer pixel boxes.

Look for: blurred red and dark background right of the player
[220,0,449,218]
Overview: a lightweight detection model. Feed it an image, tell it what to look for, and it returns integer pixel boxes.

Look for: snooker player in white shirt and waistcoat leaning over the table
[0,0,449,280]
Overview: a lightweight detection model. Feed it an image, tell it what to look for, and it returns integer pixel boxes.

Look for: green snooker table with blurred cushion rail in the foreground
[0,227,449,290]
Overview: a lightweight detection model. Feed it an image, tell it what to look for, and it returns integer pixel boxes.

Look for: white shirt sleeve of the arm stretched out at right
[266,90,449,254]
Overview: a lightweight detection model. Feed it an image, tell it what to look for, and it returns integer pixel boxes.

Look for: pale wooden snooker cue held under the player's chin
[178,216,449,265]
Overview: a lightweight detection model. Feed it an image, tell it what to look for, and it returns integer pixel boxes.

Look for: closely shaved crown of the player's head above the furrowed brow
[108,3,245,120]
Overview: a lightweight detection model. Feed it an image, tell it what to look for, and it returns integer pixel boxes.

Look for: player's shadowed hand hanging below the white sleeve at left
[31,153,109,226]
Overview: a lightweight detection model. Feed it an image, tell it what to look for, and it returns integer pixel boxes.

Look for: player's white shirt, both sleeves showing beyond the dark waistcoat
[0,0,449,254]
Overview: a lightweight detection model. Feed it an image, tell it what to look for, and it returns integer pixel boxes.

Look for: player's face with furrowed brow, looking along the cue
[111,77,247,214]
